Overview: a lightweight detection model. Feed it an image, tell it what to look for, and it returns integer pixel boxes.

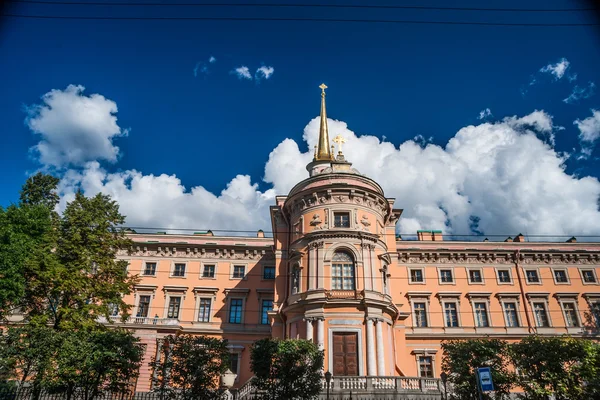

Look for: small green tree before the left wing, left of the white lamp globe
[150,335,229,400]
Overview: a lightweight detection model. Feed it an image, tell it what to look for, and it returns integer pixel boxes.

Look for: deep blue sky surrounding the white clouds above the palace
[0,1,600,234]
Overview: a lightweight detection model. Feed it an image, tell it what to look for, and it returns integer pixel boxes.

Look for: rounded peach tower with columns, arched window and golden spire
[271,84,402,376]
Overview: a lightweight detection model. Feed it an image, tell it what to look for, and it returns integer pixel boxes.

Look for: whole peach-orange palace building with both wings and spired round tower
[112,85,600,393]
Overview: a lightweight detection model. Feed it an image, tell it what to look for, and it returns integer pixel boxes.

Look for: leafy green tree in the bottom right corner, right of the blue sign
[511,336,600,400]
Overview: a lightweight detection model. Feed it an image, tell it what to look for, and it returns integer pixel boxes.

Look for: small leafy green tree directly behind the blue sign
[442,338,515,400]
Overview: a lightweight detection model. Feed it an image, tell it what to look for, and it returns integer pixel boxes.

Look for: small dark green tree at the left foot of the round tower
[250,338,323,400]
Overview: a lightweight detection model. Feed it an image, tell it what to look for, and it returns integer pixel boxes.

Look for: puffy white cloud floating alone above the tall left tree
[25,85,128,168]
